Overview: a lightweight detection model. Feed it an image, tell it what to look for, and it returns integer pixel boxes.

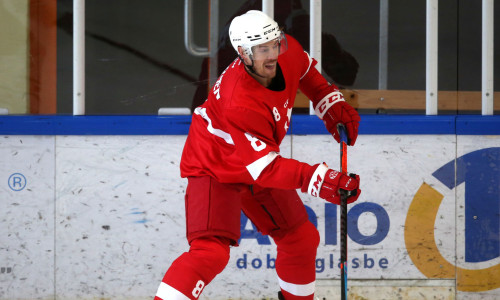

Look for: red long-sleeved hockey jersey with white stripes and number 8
[181,36,337,189]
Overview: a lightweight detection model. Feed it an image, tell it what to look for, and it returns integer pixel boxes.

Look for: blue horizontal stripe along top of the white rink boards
[0,115,500,135]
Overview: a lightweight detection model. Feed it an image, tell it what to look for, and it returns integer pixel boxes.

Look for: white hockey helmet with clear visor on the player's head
[229,10,287,57]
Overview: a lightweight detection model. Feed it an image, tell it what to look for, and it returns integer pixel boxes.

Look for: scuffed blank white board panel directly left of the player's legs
[56,136,187,299]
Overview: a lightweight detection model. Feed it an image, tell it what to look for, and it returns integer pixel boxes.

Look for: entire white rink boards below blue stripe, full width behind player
[0,135,500,299]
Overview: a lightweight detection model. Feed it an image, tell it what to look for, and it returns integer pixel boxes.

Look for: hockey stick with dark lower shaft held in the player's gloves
[337,124,349,300]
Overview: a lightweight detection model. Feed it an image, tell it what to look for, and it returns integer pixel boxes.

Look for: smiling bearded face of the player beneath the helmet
[252,39,280,79]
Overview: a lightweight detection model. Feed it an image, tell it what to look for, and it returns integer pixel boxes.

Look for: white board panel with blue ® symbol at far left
[0,136,55,299]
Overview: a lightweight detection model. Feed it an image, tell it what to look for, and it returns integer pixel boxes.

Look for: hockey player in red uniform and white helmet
[155,11,361,300]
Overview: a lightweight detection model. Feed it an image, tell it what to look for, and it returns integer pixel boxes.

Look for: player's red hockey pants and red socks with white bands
[155,177,319,300]
